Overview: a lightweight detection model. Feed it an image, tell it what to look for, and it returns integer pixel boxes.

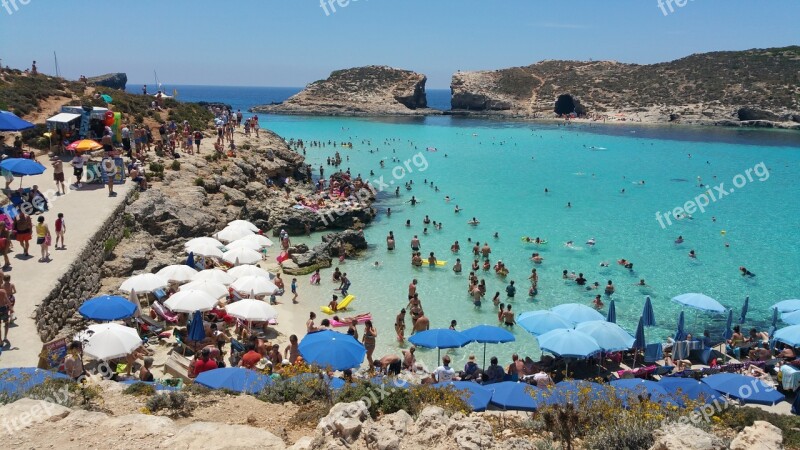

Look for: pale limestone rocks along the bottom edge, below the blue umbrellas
[0,394,783,450]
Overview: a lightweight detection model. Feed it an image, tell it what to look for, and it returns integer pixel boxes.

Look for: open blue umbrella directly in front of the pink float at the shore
[298,330,367,370]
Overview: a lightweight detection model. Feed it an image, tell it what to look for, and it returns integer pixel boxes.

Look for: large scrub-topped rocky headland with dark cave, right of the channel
[451,46,800,123]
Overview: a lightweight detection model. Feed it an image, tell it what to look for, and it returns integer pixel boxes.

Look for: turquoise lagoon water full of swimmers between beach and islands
[262,116,800,370]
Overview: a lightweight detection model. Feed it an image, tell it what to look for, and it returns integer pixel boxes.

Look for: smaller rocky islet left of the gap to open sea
[251,66,436,116]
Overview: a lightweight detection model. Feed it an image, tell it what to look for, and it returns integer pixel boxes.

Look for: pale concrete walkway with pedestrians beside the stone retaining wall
[0,156,134,368]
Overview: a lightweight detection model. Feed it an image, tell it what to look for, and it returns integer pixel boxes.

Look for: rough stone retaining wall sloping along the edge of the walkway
[34,189,138,342]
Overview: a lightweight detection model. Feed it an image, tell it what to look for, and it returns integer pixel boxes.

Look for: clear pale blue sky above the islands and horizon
[0,0,800,88]
